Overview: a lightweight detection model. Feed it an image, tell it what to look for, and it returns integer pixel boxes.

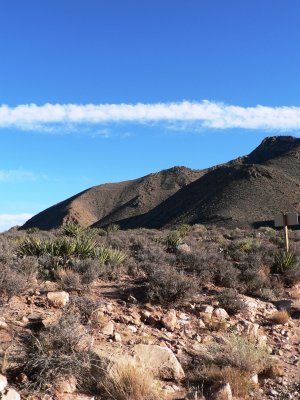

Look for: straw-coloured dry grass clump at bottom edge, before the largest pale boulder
[100,362,162,400]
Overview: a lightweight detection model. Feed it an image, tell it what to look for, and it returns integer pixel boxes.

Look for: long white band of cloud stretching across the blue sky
[0,100,300,132]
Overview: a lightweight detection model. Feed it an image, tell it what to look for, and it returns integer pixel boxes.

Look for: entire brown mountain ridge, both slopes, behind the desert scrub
[23,136,300,230]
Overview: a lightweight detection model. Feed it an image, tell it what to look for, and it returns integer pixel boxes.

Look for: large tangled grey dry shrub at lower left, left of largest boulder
[14,314,95,391]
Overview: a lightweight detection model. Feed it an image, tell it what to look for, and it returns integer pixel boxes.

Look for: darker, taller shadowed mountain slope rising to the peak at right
[106,136,300,228]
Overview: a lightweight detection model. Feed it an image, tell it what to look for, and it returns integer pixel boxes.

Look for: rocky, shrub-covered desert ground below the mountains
[0,223,300,400]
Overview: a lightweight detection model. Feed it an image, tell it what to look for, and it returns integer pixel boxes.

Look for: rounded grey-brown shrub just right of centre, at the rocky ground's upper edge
[147,265,199,304]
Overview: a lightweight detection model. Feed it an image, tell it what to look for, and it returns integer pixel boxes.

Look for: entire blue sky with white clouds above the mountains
[0,0,300,230]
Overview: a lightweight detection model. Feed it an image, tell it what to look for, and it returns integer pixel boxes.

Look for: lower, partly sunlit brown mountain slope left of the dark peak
[22,167,203,230]
